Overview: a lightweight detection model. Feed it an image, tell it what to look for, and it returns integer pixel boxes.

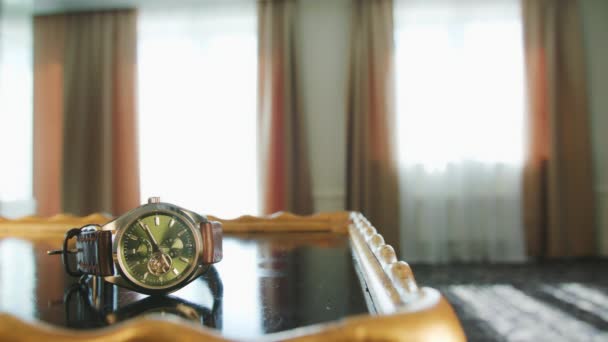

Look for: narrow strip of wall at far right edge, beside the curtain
[581,0,608,255]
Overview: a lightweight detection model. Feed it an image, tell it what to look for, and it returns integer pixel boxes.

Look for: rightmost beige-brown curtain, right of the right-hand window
[523,0,598,257]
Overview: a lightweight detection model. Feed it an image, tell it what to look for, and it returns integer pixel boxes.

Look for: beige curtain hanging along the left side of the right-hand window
[346,0,400,251]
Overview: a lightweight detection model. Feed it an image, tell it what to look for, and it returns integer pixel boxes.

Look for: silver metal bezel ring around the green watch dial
[109,203,203,294]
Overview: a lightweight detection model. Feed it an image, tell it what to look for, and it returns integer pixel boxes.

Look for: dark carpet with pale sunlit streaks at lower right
[411,259,608,341]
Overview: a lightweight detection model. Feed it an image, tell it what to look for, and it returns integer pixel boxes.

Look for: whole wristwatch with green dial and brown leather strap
[48,197,222,294]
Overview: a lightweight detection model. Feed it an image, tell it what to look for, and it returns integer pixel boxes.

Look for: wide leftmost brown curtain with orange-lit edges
[34,10,140,215]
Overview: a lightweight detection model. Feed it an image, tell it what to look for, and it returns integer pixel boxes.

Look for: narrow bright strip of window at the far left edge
[0,8,34,217]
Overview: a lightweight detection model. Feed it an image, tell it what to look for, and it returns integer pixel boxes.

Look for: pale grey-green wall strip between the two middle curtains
[296,0,350,211]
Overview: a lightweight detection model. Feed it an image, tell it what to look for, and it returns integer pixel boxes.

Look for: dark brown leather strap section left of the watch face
[76,226,114,276]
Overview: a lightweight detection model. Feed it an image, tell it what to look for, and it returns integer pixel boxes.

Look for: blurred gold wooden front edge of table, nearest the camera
[0,294,465,342]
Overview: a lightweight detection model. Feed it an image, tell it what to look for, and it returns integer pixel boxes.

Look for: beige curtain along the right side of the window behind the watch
[258,0,313,214]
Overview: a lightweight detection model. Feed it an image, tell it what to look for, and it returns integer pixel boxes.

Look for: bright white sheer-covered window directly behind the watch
[138,1,258,218]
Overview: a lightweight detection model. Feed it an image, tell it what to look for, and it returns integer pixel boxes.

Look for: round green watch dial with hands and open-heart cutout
[118,213,197,288]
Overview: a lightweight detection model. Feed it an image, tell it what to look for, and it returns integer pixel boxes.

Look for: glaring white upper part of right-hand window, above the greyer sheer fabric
[395,0,524,170]
